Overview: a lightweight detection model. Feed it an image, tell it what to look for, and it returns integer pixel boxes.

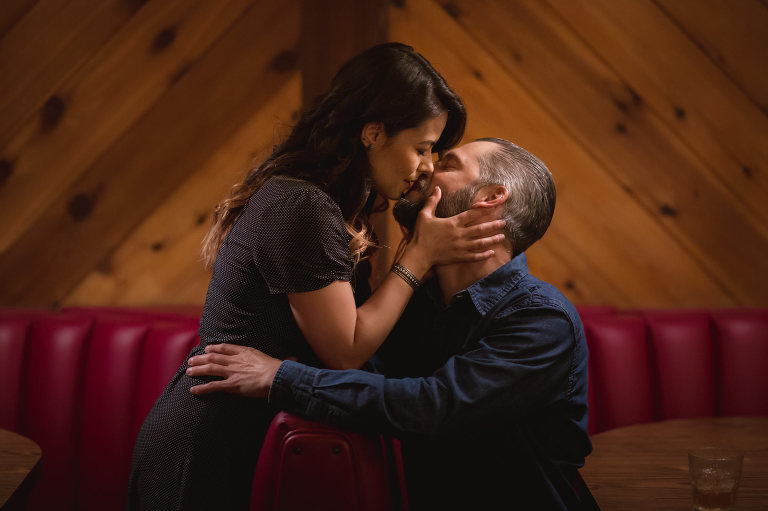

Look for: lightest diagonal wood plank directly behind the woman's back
[62,78,301,306]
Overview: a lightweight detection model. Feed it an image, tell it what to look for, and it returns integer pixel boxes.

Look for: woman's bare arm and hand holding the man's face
[288,188,504,369]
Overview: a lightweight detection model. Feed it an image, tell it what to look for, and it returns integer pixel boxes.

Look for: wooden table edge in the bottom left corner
[0,429,40,508]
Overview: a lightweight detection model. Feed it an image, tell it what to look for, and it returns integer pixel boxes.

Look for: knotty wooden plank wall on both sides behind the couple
[0,0,768,307]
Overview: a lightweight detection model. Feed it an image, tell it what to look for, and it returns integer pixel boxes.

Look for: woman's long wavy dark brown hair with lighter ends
[202,43,466,268]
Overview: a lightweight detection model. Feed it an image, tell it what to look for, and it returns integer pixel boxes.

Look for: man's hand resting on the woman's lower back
[187,344,282,398]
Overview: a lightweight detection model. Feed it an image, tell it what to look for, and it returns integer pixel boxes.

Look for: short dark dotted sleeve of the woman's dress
[253,178,352,294]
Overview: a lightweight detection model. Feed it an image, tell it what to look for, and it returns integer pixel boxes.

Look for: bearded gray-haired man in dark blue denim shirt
[188,138,597,511]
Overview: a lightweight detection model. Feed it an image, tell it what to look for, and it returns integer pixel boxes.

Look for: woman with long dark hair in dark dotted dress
[129,43,503,510]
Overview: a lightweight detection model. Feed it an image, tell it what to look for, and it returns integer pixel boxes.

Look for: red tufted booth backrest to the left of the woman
[0,309,198,510]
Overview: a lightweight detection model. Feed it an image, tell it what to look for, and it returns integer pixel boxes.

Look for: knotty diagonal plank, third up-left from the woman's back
[0,0,251,253]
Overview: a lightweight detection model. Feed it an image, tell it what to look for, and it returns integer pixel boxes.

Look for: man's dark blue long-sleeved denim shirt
[269,254,591,509]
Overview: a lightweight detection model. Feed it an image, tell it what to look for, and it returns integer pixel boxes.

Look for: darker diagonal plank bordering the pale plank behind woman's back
[0,0,298,306]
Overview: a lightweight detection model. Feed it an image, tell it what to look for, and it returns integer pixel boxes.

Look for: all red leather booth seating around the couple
[0,307,768,511]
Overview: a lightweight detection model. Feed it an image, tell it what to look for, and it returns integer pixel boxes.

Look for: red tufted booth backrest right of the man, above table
[583,309,768,433]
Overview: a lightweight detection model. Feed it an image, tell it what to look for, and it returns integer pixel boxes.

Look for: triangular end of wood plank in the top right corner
[654,0,768,115]
